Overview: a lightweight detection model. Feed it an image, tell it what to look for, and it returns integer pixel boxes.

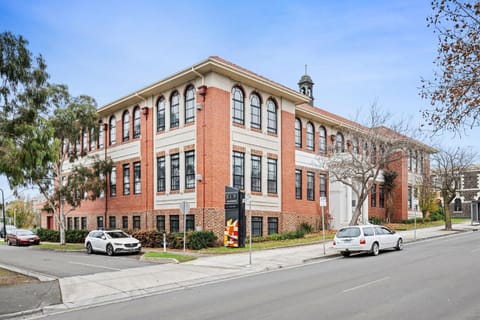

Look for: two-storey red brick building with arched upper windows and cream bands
[42,57,433,235]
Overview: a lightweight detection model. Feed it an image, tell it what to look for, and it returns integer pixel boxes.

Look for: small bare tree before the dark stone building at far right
[432,148,477,230]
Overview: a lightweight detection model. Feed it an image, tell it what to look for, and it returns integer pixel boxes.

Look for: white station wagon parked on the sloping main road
[333,224,403,257]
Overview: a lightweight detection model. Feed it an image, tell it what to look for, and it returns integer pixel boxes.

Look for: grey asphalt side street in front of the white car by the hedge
[0,245,154,278]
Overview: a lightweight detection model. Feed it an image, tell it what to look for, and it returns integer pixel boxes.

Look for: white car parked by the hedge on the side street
[85,230,142,256]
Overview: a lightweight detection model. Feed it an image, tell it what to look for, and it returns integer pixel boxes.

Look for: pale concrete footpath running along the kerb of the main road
[0,222,479,319]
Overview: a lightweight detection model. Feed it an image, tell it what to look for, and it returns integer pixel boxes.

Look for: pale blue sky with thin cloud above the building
[0,0,480,201]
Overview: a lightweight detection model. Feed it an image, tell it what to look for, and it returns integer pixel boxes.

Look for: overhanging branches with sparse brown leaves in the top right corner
[420,0,480,132]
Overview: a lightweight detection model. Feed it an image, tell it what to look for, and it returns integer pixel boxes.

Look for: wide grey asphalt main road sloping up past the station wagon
[36,232,480,320]
